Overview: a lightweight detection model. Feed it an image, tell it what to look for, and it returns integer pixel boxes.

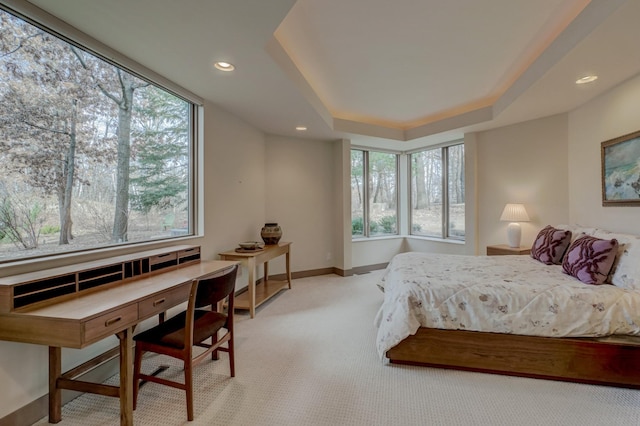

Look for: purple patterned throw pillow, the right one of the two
[562,235,618,284]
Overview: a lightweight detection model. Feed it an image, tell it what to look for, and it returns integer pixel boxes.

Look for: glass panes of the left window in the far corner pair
[351,149,398,238]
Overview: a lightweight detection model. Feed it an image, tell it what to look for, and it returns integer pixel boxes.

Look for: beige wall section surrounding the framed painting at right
[569,76,640,234]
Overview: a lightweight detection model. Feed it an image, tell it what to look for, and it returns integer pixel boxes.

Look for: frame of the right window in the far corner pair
[407,139,466,242]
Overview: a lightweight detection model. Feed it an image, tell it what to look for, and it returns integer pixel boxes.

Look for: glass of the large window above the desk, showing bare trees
[0,10,196,262]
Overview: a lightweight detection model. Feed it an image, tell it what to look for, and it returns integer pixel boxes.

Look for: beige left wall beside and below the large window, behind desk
[0,100,265,418]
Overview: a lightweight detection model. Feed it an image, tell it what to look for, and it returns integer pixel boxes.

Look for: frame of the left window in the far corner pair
[349,145,401,241]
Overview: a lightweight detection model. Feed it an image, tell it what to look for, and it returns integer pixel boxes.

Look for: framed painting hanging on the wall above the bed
[600,131,640,206]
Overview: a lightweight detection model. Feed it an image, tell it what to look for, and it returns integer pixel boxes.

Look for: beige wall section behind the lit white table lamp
[475,114,569,254]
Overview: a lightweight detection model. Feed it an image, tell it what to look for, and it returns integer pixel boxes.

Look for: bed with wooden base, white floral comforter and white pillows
[375,227,640,388]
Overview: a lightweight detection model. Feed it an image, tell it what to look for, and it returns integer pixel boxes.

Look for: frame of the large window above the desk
[0,0,204,266]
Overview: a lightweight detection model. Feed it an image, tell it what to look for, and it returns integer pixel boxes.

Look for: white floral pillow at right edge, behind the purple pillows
[593,229,640,290]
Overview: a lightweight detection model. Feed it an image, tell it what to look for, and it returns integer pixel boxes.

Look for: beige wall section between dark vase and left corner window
[265,136,341,274]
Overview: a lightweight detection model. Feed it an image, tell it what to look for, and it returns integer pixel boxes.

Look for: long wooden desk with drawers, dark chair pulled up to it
[0,255,237,426]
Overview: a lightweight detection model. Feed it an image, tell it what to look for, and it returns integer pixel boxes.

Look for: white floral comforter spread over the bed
[376,253,640,357]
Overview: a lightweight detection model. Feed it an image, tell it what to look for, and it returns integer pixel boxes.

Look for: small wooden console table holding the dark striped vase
[220,242,291,318]
